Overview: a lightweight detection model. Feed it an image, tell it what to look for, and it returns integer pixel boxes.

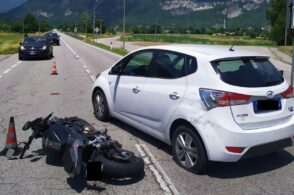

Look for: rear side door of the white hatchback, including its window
[141,51,194,131]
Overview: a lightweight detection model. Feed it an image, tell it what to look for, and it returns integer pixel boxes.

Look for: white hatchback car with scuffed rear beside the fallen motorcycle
[92,45,294,173]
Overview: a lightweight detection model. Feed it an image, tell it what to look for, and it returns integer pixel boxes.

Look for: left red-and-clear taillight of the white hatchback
[199,89,251,110]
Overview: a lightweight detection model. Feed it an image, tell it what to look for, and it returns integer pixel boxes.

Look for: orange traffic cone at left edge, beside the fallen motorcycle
[1,117,17,155]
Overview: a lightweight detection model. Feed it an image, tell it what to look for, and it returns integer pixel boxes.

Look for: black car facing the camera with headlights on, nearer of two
[18,36,53,60]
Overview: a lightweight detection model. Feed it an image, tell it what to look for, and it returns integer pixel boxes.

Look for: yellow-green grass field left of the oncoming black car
[0,33,23,54]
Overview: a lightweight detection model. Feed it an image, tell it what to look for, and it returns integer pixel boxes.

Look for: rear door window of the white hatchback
[152,51,186,79]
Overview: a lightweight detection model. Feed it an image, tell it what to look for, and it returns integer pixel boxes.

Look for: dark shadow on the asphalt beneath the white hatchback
[110,119,294,179]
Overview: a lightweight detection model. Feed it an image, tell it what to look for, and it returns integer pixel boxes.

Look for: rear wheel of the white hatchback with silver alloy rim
[172,125,209,174]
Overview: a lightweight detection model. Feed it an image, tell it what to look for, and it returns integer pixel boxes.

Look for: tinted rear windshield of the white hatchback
[212,58,284,87]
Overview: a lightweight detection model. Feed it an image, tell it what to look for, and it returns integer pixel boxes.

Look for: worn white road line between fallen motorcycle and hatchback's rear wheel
[135,144,180,195]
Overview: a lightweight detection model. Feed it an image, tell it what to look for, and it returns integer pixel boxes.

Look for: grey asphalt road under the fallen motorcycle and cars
[0,34,294,195]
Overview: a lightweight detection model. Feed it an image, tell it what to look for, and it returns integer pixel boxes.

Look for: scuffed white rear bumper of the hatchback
[192,110,294,162]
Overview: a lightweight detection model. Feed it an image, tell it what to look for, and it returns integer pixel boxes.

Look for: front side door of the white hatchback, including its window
[110,51,153,123]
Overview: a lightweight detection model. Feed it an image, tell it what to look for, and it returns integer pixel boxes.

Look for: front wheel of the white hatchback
[93,89,110,122]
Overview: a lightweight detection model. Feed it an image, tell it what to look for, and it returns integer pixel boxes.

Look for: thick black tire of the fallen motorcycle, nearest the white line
[95,155,144,179]
